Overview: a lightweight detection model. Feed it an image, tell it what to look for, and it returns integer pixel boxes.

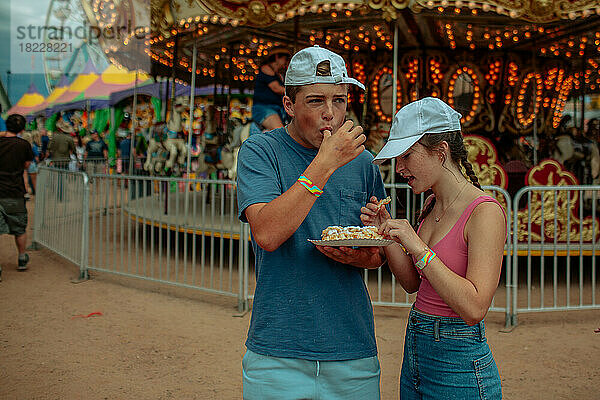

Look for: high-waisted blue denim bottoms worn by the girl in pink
[400,307,502,400]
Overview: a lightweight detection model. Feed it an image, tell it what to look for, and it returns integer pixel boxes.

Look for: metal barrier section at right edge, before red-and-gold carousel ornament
[510,185,600,325]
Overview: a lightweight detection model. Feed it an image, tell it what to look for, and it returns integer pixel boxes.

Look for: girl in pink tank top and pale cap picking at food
[361,97,506,400]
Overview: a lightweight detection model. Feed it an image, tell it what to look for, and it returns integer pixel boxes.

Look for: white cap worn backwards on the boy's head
[285,46,365,90]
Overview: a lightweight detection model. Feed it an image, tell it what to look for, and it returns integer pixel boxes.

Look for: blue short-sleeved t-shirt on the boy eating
[237,128,385,361]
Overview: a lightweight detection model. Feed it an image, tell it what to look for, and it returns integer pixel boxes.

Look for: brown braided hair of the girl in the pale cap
[415,131,481,229]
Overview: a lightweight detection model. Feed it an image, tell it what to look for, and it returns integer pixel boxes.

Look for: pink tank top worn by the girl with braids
[415,196,500,318]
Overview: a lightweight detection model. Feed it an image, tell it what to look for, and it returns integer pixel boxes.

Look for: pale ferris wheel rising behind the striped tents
[43,0,108,92]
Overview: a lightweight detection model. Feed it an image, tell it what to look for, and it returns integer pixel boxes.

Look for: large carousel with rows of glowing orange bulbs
[21,0,600,242]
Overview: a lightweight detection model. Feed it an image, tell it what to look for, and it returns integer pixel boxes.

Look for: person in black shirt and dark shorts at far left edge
[0,114,33,279]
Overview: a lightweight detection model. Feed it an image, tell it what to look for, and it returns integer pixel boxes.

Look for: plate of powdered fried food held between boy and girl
[308,226,394,247]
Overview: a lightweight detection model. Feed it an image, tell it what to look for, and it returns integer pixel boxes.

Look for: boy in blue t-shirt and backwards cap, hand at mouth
[237,46,385,400]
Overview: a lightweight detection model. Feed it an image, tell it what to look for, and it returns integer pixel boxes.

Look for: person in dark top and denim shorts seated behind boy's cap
[252,47,290,131]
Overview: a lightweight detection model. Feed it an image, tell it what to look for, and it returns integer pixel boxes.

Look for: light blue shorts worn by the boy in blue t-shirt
[242,350,381,400]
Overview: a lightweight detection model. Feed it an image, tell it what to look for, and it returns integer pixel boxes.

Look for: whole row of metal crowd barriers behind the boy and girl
[34,167,600,326]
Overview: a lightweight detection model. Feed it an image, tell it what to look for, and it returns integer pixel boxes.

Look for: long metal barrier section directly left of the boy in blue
[87,175,244,308]
